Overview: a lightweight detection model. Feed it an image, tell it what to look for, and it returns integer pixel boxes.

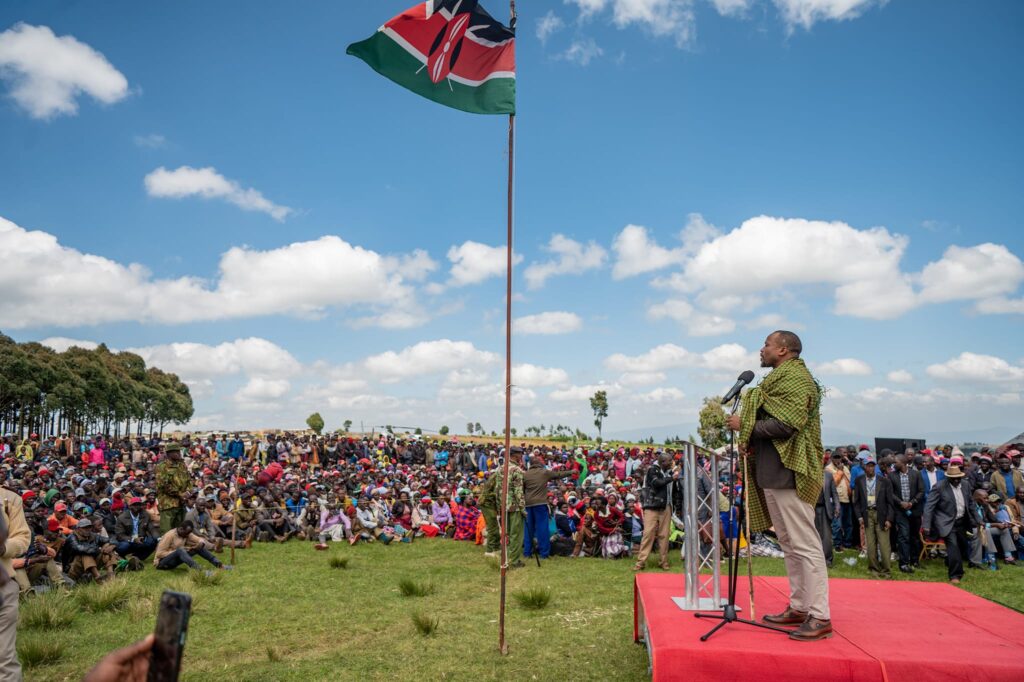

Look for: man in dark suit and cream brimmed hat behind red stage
[921,464,978,585]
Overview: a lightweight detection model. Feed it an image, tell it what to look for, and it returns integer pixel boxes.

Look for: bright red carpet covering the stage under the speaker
[633,573,1024,682]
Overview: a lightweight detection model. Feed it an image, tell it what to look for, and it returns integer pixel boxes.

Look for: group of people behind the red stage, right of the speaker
[816,443,1024,583]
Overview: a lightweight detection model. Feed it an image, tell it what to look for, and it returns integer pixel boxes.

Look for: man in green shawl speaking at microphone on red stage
[728,331,833,642]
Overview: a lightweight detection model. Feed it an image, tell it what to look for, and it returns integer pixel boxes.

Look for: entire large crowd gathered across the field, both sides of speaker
[0,433,1024,592]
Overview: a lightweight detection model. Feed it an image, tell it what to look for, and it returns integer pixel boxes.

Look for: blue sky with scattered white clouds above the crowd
[0,0,1024,438]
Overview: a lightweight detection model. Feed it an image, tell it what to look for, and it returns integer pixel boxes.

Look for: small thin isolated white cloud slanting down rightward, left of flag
[145,166,292,222]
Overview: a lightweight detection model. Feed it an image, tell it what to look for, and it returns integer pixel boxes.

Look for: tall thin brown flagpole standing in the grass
[498,0,516,655]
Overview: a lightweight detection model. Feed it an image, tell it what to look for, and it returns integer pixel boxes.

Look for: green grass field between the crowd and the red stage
[18,540,1024,682]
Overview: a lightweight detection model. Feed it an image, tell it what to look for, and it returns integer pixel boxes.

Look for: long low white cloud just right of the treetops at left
[128,337,302,379]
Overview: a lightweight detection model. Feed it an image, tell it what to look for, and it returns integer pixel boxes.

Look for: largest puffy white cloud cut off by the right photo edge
[920,244,1024,303]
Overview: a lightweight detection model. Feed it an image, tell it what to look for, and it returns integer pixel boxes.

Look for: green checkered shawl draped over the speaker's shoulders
[739,357,823,532]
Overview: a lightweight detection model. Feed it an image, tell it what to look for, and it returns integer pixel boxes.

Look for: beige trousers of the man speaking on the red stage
[765,488,830,621]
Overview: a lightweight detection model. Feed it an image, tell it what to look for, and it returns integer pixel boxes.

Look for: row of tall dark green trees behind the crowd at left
[0,334,195,438]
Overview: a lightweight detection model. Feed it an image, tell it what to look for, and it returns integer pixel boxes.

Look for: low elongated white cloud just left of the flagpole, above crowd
[361,339,499,382]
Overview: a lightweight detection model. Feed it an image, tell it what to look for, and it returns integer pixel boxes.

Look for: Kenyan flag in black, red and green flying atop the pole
[348,0,515,114]
